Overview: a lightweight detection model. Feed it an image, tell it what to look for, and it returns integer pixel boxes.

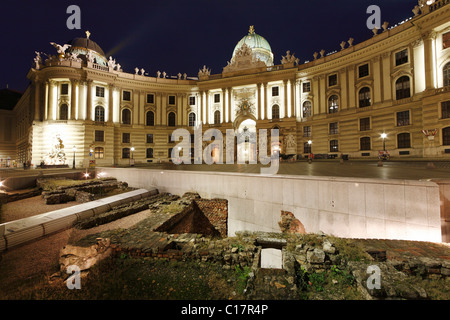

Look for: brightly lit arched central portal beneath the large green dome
[234,119,257,163]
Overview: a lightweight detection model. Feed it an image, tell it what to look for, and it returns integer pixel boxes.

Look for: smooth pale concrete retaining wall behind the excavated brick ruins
[98,168,441,242]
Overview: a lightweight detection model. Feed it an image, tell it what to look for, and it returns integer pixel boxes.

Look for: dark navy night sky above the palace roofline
[0,0,417,91]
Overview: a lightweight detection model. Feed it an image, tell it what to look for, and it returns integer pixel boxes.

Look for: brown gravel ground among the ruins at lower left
[0,196,153,299]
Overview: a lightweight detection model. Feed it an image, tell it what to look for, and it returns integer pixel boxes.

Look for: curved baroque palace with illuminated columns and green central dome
[0,0,450,167]
